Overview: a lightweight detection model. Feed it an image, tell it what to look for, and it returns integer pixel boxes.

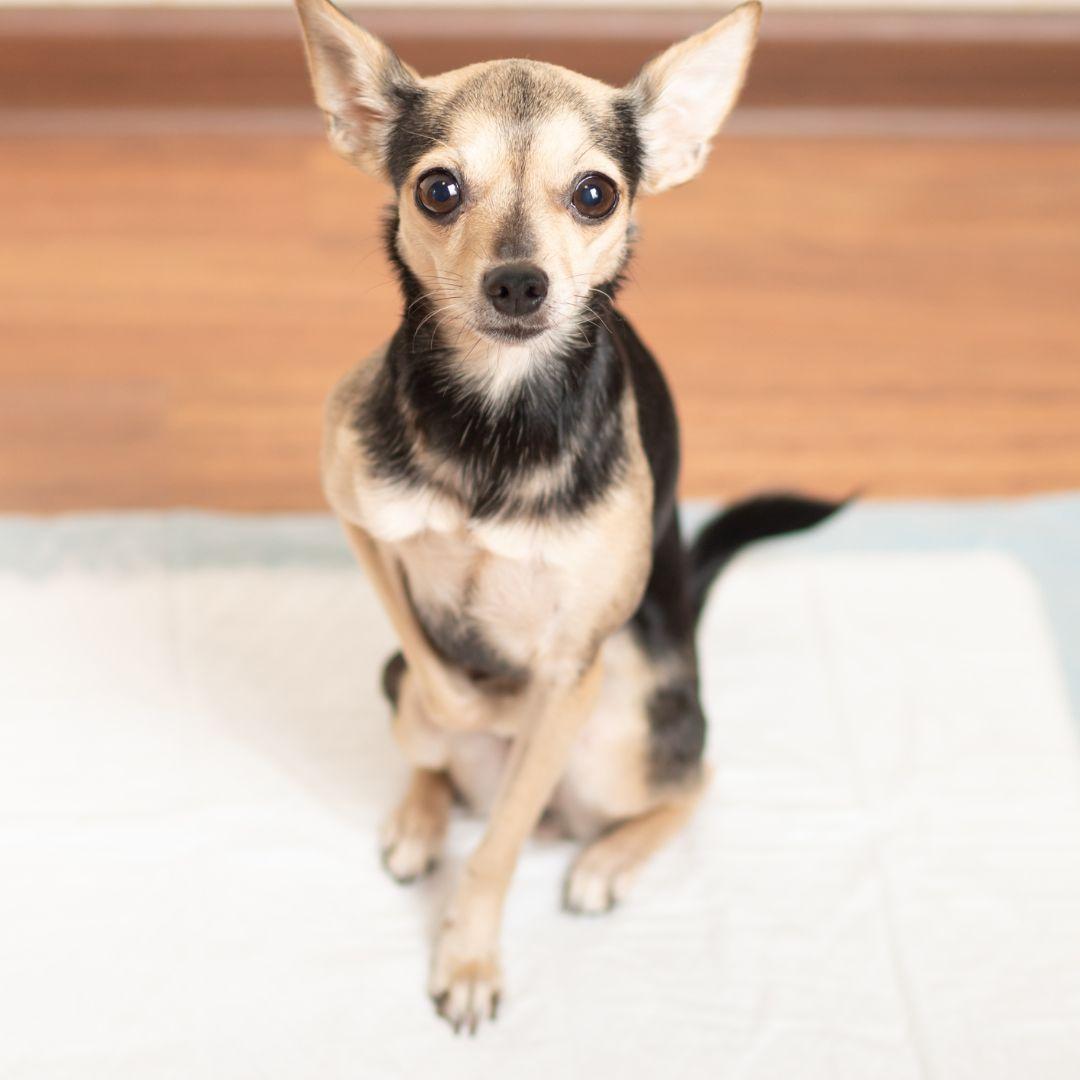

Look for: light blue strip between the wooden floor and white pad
[0,495,1080,721]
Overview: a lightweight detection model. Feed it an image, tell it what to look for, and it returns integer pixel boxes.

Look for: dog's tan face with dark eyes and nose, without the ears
[397,60,638,341]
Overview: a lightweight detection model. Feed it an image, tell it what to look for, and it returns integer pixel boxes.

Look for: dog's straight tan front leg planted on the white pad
[429,656,602,1031]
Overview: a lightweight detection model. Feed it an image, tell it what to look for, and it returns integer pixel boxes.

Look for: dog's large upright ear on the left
[296,0,421,180]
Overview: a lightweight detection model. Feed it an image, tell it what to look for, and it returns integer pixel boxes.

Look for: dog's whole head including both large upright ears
[297,0,760,362]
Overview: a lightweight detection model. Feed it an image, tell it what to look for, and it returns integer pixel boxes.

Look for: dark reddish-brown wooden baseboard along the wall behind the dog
[0,9,1080,113]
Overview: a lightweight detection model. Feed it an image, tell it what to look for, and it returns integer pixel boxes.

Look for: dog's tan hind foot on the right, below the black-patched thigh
[563,774,705,915]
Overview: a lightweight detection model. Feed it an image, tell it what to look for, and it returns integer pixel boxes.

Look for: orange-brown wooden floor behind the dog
[0,129,1080,511]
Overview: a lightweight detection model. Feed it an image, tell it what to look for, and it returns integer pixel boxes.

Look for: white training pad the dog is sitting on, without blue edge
[0,531,1080,1080]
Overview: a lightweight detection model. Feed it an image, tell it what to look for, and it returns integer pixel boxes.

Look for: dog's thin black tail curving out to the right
[690,495,851,619]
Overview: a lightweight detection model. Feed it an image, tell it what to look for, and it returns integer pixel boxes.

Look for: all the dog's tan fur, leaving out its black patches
[297,0,760,1027]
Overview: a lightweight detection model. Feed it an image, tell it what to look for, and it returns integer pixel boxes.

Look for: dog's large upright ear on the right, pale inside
[625,0,761,194]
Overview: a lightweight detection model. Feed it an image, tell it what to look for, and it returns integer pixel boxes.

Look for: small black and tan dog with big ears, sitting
[297,0,836,1031]
